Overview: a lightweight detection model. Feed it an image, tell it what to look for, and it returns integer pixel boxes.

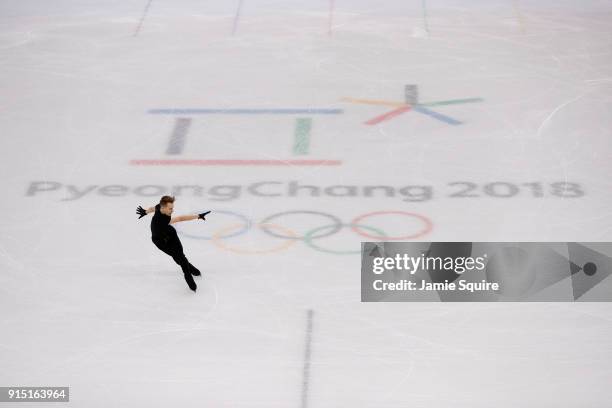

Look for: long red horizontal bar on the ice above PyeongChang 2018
[130,159,342,166]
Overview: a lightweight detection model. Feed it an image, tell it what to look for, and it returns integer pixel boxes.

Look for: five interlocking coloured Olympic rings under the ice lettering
[178,210,433,255]
